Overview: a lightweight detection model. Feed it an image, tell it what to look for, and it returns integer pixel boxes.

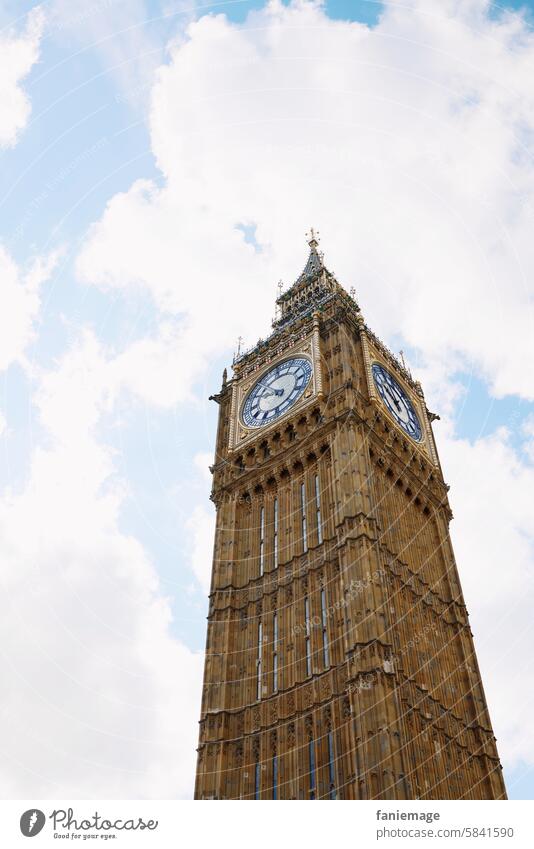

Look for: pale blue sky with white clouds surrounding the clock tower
[0,0,534,798]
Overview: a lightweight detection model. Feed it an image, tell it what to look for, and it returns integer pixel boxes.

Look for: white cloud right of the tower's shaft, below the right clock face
[439,428,534,768]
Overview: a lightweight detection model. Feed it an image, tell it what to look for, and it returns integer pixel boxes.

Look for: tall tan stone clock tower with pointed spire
[195,231,506,799]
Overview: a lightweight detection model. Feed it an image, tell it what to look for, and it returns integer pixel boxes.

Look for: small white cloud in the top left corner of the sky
[0,7,44,148]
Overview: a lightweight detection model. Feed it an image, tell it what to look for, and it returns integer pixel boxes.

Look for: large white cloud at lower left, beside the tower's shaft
[0,334,202,798]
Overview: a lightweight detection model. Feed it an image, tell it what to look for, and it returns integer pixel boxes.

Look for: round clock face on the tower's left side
[241,357,312,427]
